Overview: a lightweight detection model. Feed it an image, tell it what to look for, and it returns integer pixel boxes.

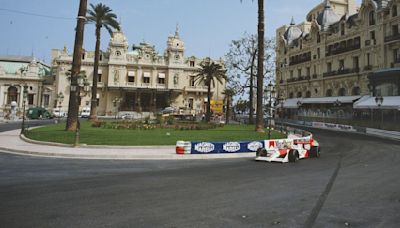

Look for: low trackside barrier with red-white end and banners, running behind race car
[176,127,312,154]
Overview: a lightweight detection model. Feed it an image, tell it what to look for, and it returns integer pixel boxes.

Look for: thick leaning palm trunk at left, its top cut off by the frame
[65,0,87,131]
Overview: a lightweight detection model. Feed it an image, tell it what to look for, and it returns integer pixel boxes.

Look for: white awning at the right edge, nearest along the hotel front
[353,96,400,110]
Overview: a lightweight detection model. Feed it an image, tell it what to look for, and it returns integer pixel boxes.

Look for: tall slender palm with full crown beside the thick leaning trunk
[87,3,120,120]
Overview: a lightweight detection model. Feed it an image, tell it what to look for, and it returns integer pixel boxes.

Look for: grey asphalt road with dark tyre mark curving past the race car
[0,125,400,227]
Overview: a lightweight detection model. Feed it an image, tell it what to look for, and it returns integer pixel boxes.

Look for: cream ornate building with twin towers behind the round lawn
[52,29,225,115]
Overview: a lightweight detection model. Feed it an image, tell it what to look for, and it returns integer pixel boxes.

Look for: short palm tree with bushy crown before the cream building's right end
[195,58,226,122]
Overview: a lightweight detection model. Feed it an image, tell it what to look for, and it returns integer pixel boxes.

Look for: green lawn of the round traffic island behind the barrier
[27,121,285,146]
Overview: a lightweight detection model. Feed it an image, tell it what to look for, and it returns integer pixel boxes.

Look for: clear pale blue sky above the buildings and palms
[0,0,361,63]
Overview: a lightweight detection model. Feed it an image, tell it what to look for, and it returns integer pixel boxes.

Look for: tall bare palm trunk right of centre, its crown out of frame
[256,0,264,132]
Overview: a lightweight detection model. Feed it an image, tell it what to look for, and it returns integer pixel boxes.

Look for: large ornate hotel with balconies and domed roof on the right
[276,0,400,108]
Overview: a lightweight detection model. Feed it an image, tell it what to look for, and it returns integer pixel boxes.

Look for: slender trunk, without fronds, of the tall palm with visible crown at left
[89,25,101,120]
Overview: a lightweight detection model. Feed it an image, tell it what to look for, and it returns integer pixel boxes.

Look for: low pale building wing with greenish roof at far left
[0,56,54,117]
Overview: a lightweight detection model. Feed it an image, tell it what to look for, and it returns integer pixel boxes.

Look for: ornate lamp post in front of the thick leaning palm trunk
[71,71,90,147]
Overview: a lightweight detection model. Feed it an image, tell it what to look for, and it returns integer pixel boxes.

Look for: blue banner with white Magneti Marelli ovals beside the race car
[191,140,264,154]
